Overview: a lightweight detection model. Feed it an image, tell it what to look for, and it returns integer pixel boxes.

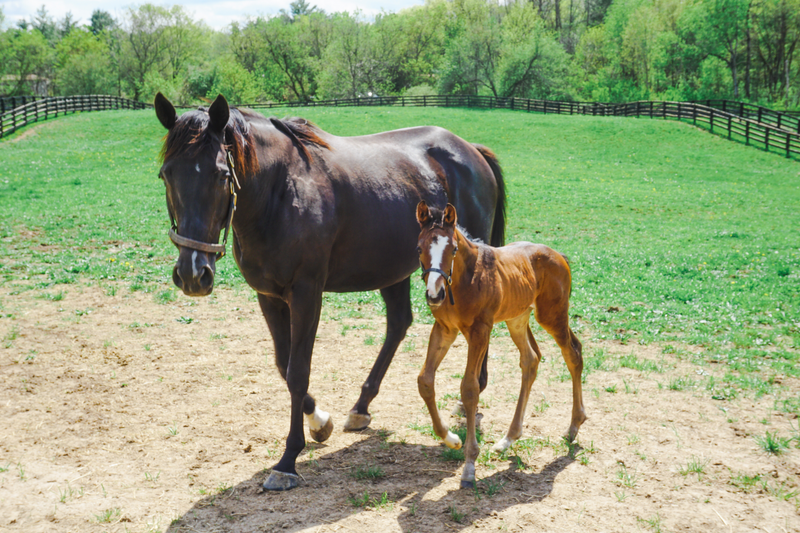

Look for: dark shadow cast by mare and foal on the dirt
[167,429,574,533]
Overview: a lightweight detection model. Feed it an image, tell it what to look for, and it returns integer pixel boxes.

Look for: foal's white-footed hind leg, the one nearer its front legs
[492,311,542,452]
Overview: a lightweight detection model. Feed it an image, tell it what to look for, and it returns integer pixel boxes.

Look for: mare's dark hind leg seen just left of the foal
[344,277,414,431]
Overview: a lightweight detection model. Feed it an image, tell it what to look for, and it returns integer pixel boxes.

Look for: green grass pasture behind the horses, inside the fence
[0,108,800,400]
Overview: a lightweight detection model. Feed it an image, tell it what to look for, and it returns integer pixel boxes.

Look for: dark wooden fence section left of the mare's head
[0,94,152,138]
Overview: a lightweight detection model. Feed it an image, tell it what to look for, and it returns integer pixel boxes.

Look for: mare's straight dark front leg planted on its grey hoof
[264,281,322,490]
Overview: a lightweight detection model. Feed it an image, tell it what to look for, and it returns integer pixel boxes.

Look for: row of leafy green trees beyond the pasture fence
[0,0,800,109]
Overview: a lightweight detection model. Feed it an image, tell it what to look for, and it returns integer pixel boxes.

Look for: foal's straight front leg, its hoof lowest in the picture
[461,320,492,489]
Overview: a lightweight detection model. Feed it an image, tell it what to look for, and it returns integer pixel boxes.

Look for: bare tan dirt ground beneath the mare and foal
[0,284,800,533]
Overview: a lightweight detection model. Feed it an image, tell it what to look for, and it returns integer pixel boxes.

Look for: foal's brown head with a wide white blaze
[417,201,458,309]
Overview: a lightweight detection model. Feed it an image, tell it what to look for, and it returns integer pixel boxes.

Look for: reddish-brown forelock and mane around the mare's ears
[161,107,263,178]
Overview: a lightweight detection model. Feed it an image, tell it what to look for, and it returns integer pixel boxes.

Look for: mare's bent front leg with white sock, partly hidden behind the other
[258,294,333,442]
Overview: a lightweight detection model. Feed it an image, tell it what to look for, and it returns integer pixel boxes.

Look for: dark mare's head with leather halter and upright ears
[155,93,257,296]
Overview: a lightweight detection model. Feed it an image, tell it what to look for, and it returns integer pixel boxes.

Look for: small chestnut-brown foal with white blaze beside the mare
[417,201,586,488]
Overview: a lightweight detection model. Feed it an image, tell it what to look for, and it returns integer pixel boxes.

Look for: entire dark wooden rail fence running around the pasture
[0,95,800,157]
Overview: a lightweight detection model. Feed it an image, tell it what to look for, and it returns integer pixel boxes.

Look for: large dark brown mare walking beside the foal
[155,94,505,490]
